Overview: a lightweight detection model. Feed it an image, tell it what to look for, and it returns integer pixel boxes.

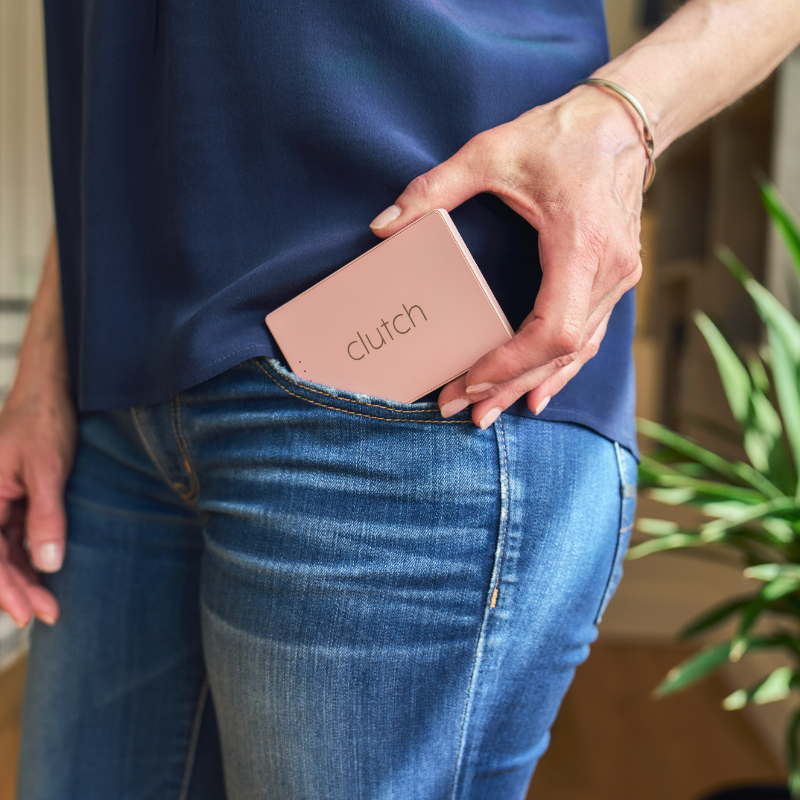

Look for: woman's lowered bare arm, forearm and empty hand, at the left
[0,235,77,627]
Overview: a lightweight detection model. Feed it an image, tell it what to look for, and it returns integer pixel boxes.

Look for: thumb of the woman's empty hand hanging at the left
[25,468,67,572]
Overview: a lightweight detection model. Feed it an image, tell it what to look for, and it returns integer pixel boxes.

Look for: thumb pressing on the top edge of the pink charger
[370,137,484,239]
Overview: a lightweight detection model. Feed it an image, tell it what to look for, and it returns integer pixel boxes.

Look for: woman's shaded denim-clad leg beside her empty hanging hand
[18,412,224,800]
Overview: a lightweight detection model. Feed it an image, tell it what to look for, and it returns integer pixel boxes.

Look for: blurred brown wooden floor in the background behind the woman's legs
[0,641,783,800]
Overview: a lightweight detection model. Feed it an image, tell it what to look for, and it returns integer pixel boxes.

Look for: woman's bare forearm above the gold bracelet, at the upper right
[589,0,800,155]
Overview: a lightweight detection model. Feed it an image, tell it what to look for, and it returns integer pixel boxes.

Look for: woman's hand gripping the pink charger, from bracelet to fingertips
[372,86,647,428]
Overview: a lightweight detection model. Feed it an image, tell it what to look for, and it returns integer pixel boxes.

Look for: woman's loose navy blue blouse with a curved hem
[44,0,635,456]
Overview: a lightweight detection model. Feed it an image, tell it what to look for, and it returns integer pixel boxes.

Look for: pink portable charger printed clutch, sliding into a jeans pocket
[266,209,513,403]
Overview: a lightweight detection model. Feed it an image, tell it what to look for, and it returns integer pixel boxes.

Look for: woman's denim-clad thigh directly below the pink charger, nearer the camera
[177,359,635,800]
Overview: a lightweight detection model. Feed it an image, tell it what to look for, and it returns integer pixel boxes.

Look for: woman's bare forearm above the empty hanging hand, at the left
[9,234,69,400]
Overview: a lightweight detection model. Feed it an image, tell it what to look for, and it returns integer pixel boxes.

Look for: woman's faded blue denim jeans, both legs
[19,358,636,800]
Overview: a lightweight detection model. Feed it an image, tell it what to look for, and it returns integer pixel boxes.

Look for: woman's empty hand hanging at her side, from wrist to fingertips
[0,384,76,627]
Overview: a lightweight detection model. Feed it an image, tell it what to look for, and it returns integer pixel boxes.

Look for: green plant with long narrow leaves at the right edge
[628,181,800,798]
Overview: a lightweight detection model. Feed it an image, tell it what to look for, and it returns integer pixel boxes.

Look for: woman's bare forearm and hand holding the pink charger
[372,0,800,428]
